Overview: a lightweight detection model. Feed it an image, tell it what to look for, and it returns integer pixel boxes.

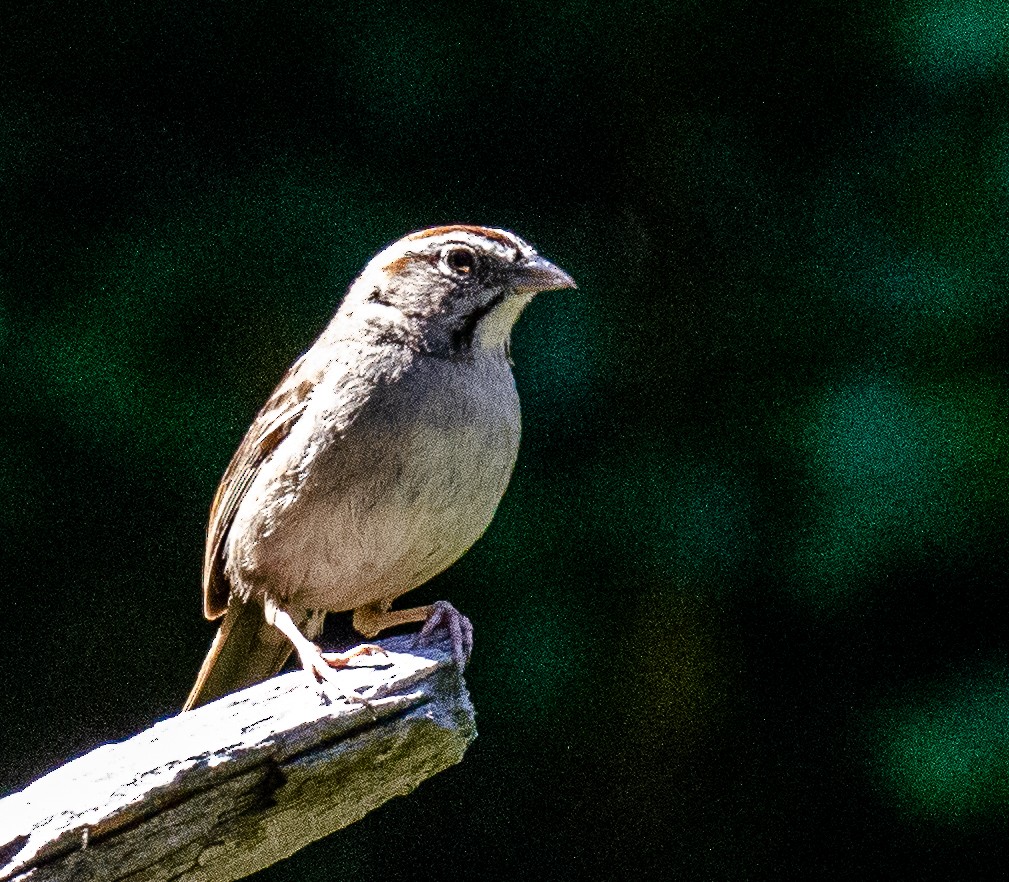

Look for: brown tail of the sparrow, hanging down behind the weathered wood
[183,596,294,710]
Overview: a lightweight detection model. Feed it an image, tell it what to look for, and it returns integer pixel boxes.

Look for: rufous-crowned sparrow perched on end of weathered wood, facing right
[183,224,577,710]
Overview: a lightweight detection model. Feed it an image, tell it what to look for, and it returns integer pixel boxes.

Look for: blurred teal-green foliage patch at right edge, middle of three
[795,377,1009,601]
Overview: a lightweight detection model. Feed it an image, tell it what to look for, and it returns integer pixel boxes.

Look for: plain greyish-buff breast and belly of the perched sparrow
[231,357,520,611]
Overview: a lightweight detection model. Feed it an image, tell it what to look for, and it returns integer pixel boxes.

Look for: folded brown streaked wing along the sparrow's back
[203,350,325,619]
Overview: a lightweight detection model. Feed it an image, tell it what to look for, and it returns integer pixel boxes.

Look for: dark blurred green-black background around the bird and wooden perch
[0,0,1009,882]
